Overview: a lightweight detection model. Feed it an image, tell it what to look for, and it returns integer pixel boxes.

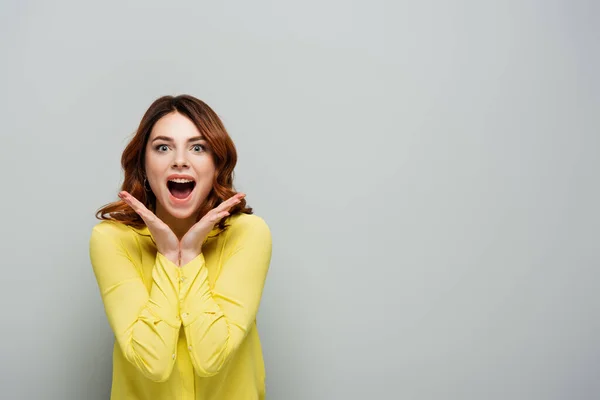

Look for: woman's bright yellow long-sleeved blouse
[90,214,271,400]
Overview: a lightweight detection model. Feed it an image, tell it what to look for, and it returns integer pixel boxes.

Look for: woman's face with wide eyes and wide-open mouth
[145,112,215,219]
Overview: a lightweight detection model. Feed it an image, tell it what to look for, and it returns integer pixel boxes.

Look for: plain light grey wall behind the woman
[0,0,600,400]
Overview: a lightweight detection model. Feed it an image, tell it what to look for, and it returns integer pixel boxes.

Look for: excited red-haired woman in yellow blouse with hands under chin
[90,95,271,400]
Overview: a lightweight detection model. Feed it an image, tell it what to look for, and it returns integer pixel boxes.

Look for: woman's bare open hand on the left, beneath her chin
[119,190,179,264]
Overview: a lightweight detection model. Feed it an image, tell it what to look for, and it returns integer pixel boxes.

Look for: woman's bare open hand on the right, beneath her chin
[179,193,246,265]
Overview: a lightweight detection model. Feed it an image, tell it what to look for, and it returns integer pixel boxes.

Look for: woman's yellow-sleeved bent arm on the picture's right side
[180,217,272,377]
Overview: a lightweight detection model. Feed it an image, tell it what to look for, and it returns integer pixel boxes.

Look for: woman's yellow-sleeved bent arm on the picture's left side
[90,224,181,382]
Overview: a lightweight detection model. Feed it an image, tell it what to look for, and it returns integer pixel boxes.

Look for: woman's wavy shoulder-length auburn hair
[96,95,252,229]
